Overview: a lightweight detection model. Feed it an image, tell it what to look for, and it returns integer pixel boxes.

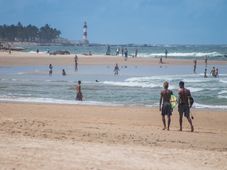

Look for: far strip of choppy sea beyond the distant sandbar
[25,44,227,60]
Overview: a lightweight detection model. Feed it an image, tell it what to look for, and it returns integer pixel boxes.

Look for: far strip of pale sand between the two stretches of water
[0,51,227,66]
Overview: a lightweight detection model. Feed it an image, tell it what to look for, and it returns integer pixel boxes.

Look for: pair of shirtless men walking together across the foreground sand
[159,81,194,132]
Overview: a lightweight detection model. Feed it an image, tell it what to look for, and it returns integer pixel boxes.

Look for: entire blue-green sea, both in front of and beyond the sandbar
[0,45,227,109]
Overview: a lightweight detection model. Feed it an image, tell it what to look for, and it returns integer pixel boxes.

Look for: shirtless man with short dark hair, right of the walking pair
[178,81,194,132]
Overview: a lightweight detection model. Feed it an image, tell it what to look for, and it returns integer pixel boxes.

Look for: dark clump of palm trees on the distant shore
[0,22,61,42]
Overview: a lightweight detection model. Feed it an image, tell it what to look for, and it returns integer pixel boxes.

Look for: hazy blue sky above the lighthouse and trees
[0,0,227,44]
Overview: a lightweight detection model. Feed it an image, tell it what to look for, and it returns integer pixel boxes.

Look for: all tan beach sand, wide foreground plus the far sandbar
[0,52,227,170]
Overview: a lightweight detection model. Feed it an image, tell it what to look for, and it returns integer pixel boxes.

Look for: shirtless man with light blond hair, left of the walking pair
[159,81,173,130]
